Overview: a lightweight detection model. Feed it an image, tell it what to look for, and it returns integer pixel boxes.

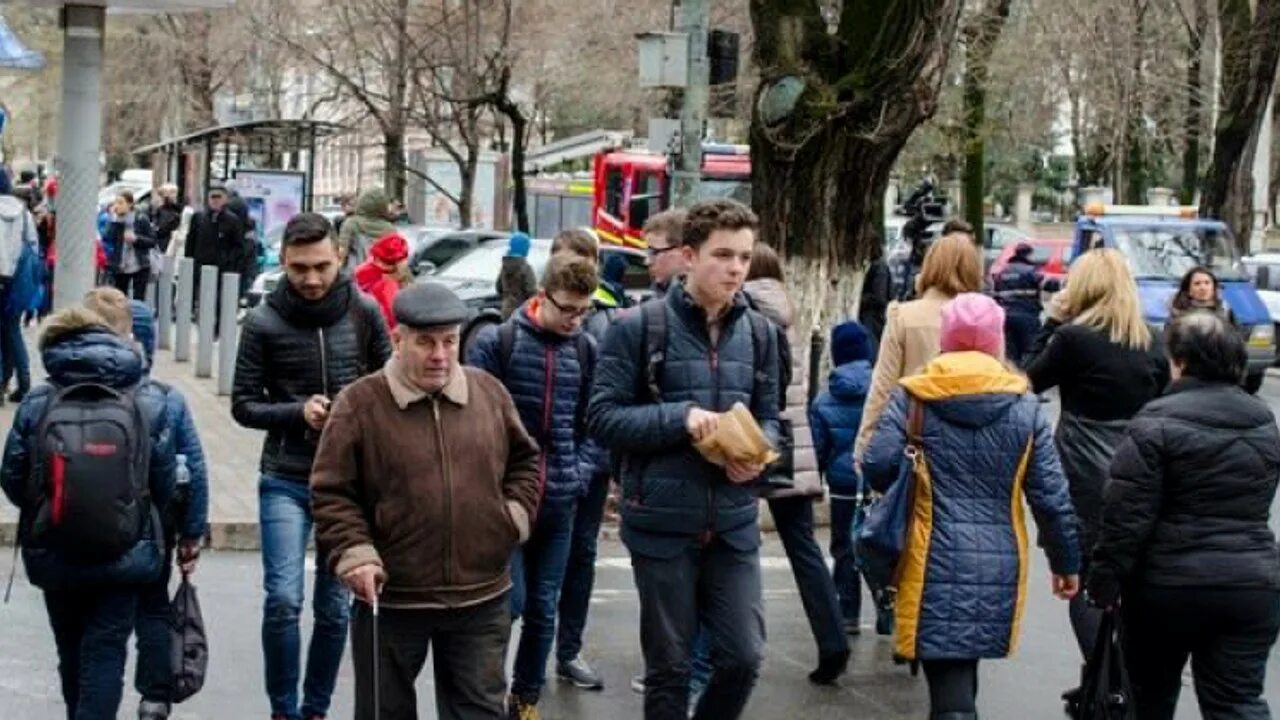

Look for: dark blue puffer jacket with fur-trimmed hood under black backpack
[0,311,174,589]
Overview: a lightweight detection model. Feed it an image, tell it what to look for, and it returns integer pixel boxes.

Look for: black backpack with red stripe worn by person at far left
[24,383,151,564]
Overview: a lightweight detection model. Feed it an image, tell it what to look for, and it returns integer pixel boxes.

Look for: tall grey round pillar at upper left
[54,5,106,310]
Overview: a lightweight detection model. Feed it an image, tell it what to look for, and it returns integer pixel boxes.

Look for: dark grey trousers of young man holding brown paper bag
[631,538,764,720]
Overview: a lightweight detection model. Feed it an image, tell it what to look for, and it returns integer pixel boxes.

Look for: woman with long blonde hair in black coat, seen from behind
[1027,249,1169,703]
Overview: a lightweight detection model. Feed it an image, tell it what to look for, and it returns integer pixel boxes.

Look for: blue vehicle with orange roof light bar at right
[1073,206,1276,392]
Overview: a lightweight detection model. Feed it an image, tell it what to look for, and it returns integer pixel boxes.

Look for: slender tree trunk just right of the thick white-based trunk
[961,0,1012,237]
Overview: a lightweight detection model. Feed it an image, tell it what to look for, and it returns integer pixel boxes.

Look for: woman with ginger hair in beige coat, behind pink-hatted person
[854,233,982,461]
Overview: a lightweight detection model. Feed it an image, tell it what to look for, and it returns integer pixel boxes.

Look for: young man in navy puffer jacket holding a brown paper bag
[589,200,780,720]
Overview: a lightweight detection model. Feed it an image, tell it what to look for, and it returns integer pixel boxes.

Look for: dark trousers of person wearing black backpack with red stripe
[45,588,138,720]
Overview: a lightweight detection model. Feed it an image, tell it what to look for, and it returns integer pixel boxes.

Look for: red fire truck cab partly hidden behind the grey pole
[591,145,751,247]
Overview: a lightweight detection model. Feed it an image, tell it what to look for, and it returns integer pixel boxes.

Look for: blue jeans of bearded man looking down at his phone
[257,474,349,720]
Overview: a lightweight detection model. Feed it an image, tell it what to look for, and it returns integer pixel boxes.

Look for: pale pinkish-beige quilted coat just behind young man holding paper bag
[742,278,822,497]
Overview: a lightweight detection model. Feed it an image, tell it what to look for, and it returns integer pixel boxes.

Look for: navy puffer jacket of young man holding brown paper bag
[589,286,778,557]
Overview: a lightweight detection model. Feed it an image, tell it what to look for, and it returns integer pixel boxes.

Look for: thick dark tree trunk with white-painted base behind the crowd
[750,0,963,330]
